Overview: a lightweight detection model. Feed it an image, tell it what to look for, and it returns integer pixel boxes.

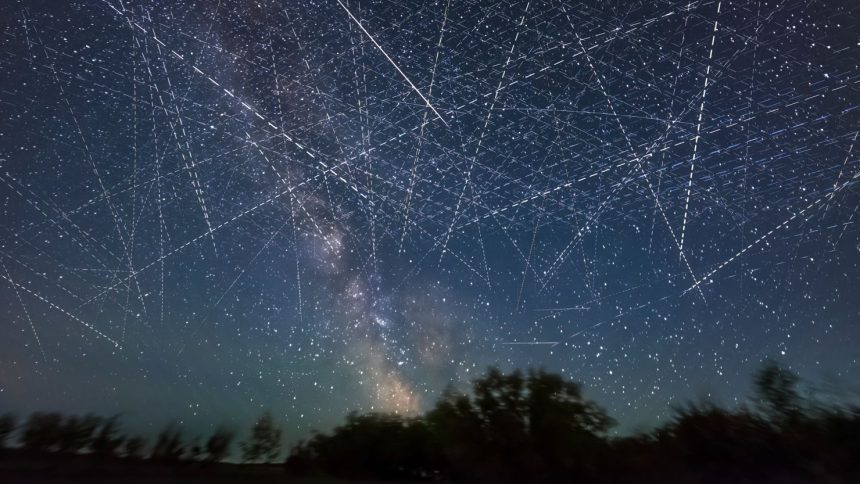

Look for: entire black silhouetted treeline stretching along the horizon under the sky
[0,362,860,483]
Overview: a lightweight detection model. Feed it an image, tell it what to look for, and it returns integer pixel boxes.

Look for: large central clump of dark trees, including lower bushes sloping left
[288,368,612,481]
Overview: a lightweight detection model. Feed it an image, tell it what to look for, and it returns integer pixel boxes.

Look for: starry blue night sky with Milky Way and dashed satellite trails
[0,0,860,440]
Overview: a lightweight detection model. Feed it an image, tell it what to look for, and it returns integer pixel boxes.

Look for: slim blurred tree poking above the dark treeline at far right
[753,360,803,426]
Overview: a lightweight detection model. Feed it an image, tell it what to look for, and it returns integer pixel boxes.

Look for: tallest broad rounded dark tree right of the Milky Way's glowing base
[427,368,613,481]
